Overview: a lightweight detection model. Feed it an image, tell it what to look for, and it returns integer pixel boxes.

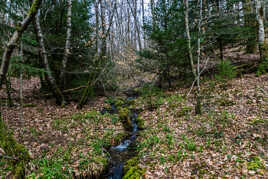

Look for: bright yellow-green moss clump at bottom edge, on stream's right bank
[123,157,146,179]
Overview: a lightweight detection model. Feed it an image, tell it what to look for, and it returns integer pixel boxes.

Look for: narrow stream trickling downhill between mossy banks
[101,97,139,179]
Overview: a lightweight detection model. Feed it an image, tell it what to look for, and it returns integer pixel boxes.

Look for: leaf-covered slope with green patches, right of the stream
[134,74,268,178]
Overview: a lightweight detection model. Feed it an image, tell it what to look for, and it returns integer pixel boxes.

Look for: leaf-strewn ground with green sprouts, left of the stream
[0,79,125,178]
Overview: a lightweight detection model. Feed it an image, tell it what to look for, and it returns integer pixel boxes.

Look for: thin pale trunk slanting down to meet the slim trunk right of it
[184,0,197,78]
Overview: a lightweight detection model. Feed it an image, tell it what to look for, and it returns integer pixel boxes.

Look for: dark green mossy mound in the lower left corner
[0,117,31,178]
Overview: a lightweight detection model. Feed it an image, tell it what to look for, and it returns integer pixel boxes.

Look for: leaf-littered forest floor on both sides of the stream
[0,74,268,178]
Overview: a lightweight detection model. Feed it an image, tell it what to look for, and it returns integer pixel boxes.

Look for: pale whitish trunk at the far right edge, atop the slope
[256,0,265,61]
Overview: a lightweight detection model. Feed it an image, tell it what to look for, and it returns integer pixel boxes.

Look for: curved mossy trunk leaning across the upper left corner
[0,0,41,89]
